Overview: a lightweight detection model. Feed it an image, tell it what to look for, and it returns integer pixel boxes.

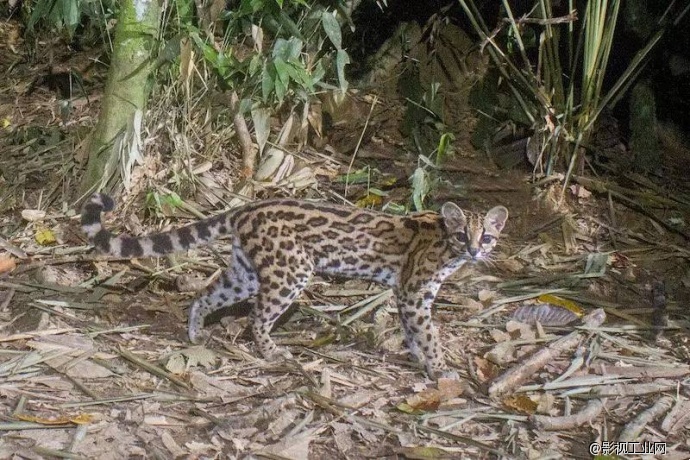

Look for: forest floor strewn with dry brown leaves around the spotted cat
[0,18,690,459]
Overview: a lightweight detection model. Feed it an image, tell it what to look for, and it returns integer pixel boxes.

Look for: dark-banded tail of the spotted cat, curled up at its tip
[81,193,231,257]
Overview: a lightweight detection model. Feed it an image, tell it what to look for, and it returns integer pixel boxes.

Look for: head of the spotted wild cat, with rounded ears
[441,203,508,260]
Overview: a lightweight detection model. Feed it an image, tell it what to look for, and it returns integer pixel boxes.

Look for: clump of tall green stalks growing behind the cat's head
[459,0,663,181]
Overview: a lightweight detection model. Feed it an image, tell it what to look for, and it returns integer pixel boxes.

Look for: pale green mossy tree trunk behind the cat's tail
[80,0,160,196]
